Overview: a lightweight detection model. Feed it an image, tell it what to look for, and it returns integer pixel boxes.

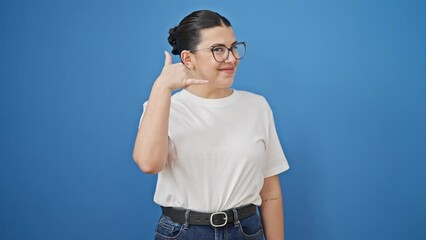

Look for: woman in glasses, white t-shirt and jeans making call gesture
[133,10,289,240]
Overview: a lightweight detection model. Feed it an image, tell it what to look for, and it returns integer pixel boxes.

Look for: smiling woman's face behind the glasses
[192,26,239,88]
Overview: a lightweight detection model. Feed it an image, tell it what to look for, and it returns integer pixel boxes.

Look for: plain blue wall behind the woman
[0,0,426,240]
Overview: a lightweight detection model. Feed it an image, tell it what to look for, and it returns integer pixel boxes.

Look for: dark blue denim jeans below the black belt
[155,214,263,240]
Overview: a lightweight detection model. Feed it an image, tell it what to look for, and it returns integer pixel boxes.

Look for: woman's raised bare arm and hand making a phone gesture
[133,52,208,174]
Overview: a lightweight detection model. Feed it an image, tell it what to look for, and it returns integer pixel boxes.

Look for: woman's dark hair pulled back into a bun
[168,10,232,55]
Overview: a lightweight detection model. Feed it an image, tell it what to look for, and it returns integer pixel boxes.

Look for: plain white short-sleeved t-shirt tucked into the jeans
[140,90,289,212]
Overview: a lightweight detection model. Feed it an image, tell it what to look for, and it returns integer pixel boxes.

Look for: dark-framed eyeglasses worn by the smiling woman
[191,42,246,63]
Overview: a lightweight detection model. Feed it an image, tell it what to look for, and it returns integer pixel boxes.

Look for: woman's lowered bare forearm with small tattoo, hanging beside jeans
[260,175,284,240]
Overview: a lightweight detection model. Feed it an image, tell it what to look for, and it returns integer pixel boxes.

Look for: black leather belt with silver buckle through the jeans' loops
[161,204,256,227]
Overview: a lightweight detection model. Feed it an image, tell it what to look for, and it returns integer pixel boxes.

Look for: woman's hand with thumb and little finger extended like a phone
[155,51,209,91]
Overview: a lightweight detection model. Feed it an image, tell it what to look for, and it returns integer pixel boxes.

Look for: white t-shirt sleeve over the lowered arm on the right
[263,105,290,178]
